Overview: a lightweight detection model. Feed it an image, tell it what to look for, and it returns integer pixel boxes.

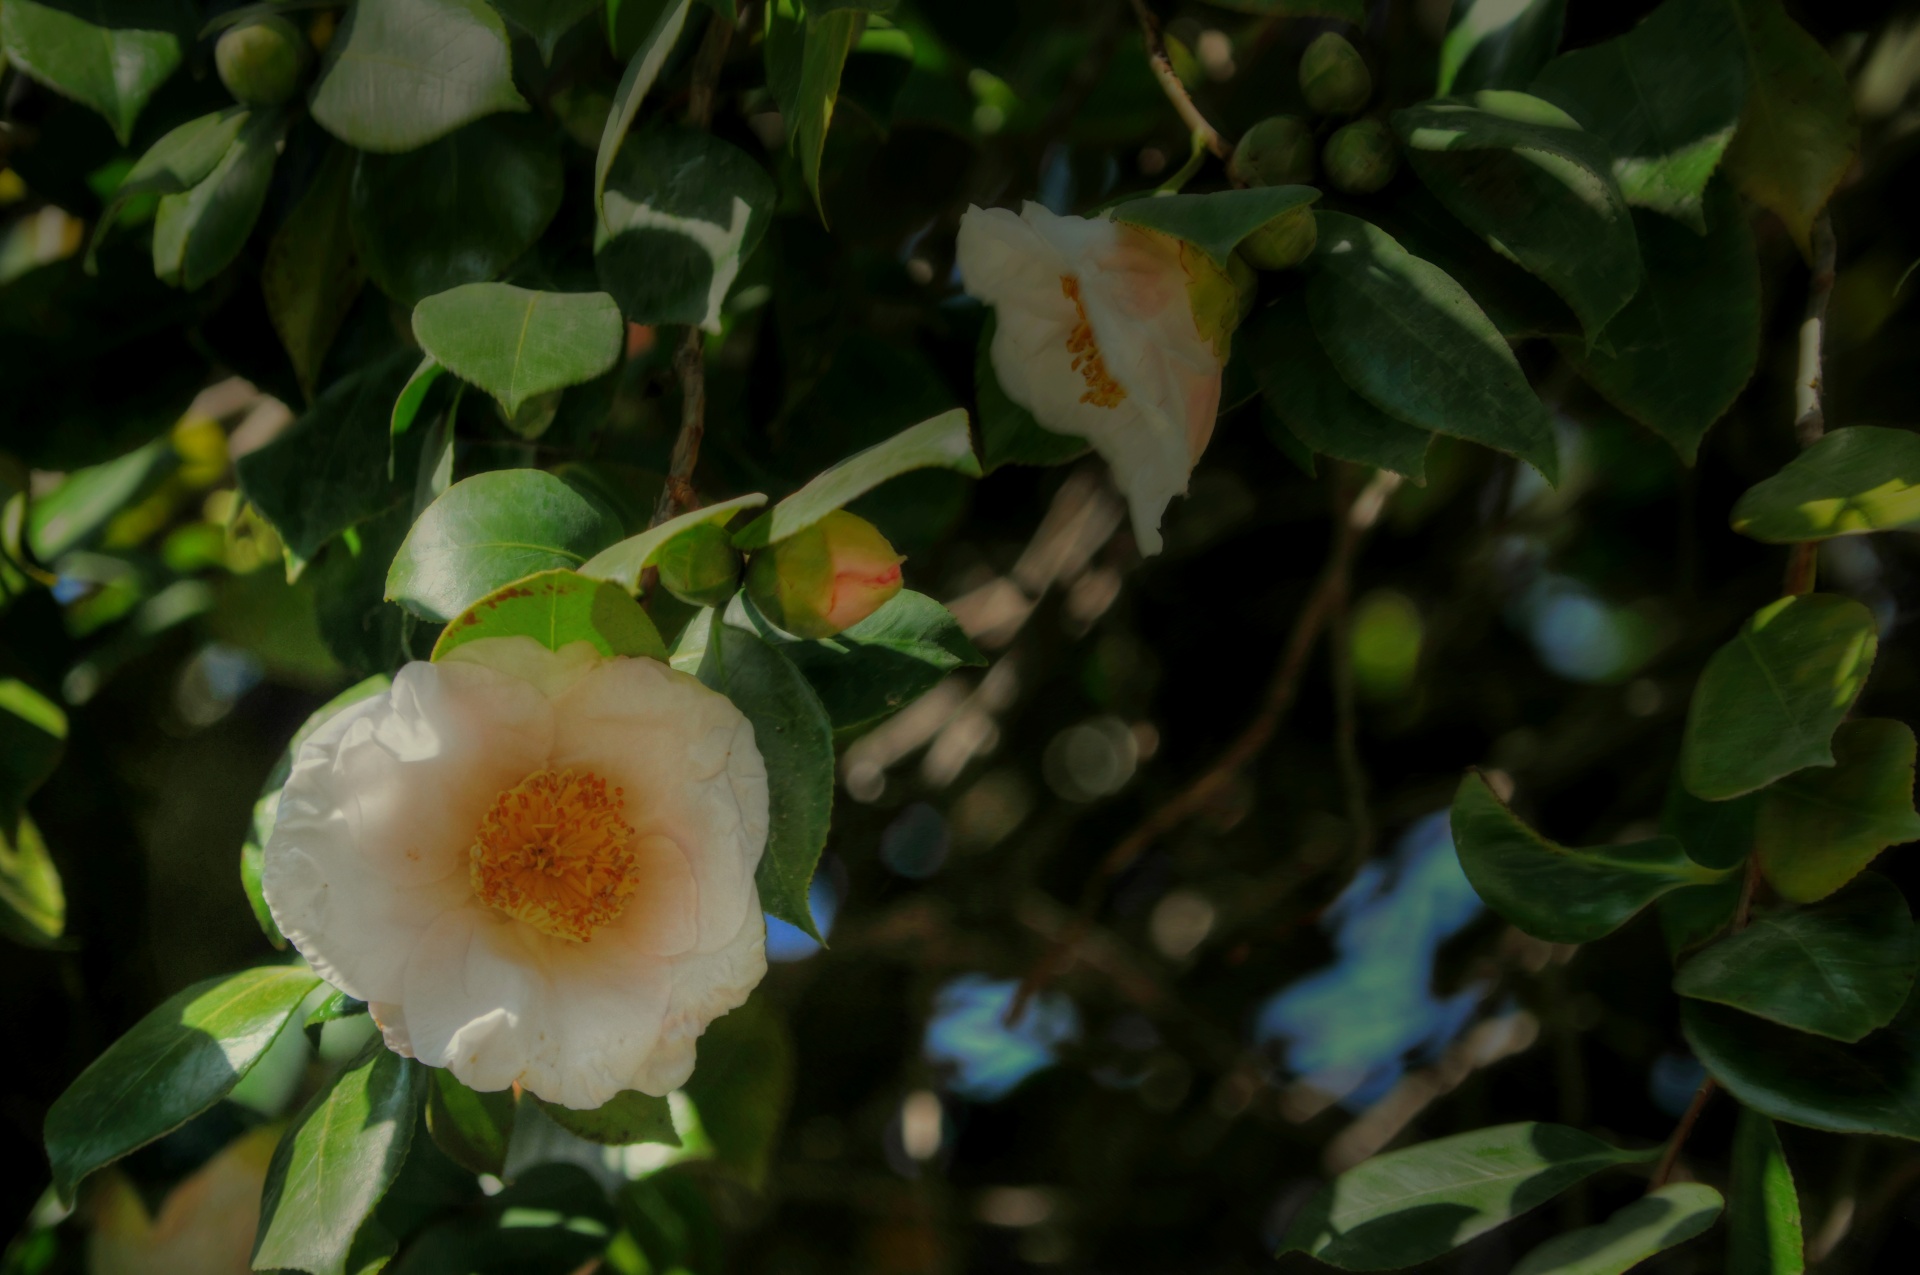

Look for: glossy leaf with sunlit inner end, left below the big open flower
[46,966,321,1200]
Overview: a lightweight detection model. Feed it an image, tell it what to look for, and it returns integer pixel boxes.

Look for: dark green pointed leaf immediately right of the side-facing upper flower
[1308,213,1559,482]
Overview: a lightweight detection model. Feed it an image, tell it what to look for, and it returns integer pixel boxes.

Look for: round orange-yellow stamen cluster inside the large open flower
[468,770,639,943]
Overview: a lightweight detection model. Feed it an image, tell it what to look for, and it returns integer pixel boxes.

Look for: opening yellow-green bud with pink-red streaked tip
[747,509,906,638]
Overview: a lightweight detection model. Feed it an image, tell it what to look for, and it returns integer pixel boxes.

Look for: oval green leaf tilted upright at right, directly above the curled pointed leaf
[1680,593,1880,801]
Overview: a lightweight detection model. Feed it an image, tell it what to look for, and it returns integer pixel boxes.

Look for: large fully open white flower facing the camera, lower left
[261,638,768,1108]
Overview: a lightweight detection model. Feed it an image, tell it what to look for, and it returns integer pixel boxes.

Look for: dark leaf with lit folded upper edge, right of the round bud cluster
[1394,92,1640,344]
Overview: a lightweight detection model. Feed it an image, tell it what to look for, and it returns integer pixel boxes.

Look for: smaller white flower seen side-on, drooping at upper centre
[958,204,1238,553]
